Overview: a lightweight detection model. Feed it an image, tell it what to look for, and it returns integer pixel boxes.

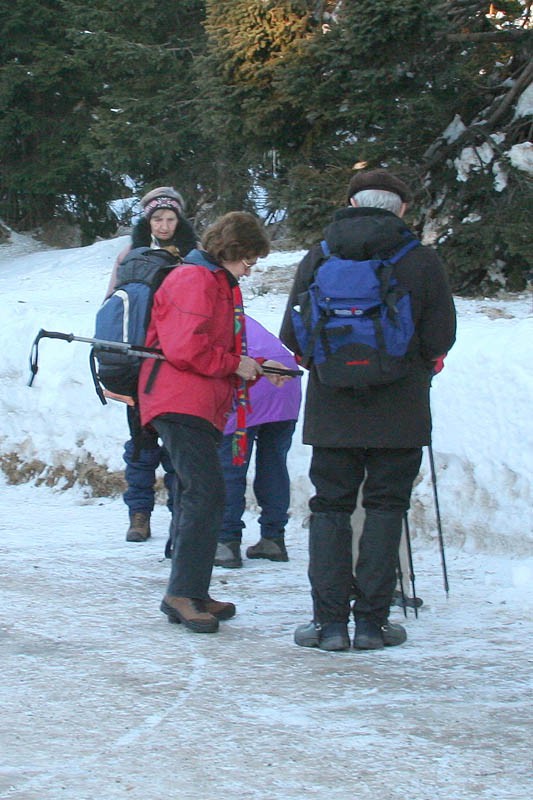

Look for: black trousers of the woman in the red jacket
[152,418,225,600]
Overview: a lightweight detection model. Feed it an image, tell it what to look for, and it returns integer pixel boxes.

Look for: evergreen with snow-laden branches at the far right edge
[421,0,533,294]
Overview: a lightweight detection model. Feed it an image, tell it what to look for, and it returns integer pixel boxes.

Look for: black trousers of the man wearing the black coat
[309,447,422,624]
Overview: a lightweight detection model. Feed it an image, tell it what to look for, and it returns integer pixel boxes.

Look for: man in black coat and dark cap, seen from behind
[280,170,456,650]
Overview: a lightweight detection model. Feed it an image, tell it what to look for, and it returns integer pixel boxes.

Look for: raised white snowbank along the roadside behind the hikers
[0,237,533,555]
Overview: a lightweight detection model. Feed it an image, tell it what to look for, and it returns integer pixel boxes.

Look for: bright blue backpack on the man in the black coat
[291,234,420,389]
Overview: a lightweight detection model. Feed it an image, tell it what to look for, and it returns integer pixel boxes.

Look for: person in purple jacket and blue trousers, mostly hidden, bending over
[214,315,302,569]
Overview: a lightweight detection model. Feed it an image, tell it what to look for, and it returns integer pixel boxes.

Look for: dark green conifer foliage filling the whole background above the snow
[0,0,533,292]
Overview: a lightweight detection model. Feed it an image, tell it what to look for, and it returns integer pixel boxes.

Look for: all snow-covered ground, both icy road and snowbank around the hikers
[0,237,533,800]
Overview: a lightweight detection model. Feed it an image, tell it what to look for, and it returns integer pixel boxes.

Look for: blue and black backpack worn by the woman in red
[91,247,179,402]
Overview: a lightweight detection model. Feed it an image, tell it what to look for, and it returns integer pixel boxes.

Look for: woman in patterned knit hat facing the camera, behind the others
[106,186,196,542]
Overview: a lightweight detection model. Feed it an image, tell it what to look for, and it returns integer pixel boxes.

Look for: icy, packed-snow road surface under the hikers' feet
[0,486,533,800]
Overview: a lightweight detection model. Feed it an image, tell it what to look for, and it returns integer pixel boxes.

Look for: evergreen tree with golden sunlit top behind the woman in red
[197,0,315,219]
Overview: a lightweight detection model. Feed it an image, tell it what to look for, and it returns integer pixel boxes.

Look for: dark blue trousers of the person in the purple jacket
[218,420,296,542]
